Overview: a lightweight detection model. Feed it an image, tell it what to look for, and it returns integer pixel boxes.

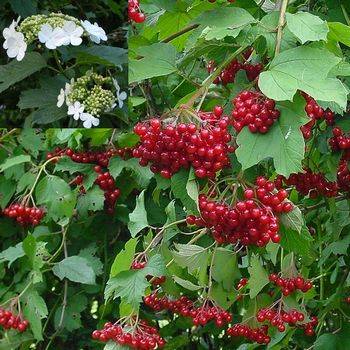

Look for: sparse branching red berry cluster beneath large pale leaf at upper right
[300,93,334,140]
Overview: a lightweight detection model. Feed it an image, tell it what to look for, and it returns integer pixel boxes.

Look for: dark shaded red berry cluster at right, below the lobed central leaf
[275,169,338,198]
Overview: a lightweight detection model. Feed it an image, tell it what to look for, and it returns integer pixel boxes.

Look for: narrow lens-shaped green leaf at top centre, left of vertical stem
[192,7,256,29]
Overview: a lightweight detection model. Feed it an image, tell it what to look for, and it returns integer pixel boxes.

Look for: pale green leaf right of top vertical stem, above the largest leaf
[286,12,329,44]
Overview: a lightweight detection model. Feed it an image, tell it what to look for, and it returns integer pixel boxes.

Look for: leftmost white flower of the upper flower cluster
[2,19,27,61]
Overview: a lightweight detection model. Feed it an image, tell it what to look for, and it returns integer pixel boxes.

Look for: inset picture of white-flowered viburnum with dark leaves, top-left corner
[0,0,127,128]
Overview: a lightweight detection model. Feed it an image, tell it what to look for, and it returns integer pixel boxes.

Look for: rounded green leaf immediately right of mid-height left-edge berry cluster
[35,175,76,221]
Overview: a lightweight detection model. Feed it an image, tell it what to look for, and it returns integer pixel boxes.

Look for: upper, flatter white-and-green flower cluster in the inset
[3,13,107,61]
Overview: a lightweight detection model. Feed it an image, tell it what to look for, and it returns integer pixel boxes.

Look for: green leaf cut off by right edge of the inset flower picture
[129,43,177,83]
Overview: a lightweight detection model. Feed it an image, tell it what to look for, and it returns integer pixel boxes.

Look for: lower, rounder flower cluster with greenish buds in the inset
[57,72,127,128]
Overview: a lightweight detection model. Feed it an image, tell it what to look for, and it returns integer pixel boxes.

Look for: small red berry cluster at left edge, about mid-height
[3,203,45,226]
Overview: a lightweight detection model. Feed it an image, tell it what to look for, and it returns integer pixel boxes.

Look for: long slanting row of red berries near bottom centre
[144,293,232,327]
